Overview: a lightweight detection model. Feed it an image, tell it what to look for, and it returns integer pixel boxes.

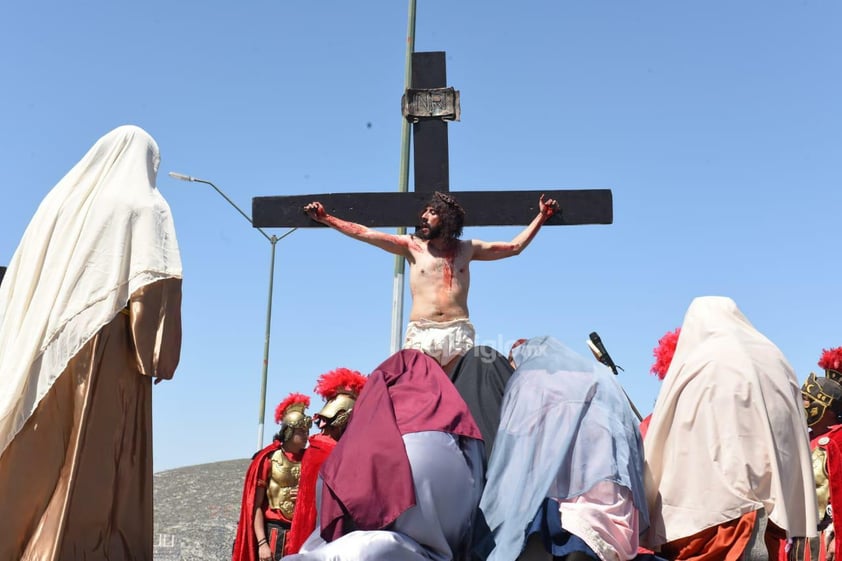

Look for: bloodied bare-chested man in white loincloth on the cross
[304,191,559,372]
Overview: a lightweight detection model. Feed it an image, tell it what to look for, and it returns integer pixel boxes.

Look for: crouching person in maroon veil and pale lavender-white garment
[284,349,483,561]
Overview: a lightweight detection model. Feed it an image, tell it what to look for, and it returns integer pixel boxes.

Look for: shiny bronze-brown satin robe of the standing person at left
[0,278,181,561]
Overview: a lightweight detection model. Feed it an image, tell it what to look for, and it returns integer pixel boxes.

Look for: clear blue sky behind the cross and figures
[0,0,842,471]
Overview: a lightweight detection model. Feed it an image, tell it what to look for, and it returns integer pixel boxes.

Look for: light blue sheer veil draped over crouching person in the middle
[476,337,649,561]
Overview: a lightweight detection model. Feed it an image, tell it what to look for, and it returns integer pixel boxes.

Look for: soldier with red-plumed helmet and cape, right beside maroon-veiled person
[287,368,366,553]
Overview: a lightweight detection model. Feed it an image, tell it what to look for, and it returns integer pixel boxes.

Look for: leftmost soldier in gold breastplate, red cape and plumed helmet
[233,393,313,561]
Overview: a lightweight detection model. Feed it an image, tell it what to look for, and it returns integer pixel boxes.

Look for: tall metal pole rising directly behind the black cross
[390,0,416,354]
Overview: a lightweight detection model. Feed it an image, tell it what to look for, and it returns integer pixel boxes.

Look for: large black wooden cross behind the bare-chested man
[252,52,613,228]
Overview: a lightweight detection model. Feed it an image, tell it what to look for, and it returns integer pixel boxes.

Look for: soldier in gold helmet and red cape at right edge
[795,347,842,561]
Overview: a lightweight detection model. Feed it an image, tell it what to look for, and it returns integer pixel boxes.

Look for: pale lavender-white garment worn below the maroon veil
[284,431,483,561]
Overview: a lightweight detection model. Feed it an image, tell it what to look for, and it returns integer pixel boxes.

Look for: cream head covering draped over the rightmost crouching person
[644,296,816,547]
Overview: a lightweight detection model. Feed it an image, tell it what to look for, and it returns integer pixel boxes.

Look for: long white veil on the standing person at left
[0,126,181,453]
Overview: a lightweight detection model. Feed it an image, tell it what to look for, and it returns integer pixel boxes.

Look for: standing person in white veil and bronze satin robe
[0,126,181,561]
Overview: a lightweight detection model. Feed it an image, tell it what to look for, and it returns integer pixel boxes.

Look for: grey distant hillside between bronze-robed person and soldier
[153,459,249,561]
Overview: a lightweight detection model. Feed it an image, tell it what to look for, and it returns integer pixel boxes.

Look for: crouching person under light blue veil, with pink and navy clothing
[474,336,649,561]
